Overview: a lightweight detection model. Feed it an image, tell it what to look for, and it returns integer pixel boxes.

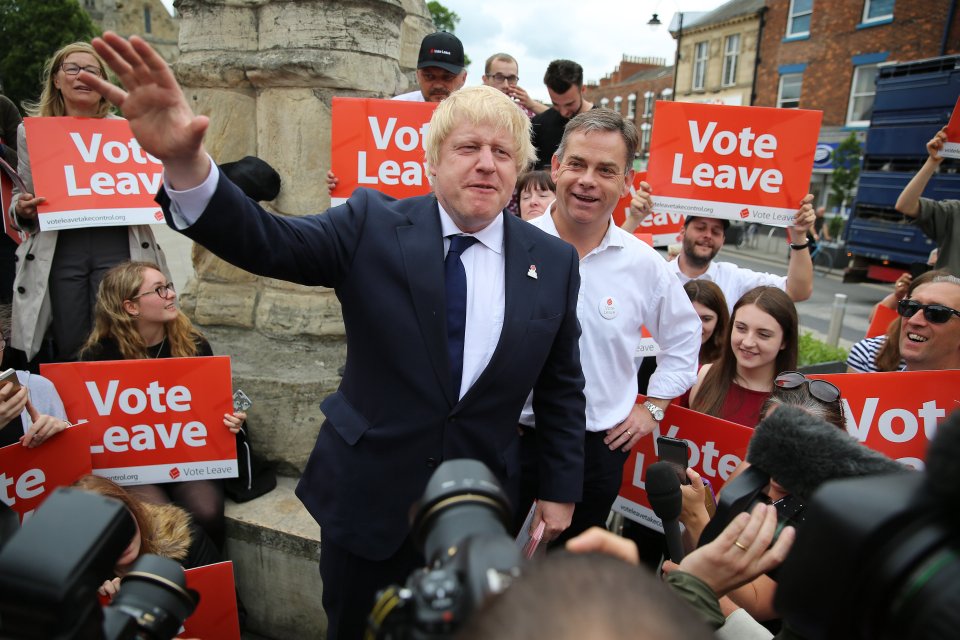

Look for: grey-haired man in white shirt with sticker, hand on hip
[517,109,701,537]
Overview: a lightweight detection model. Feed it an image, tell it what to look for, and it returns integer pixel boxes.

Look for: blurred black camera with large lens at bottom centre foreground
[366,460,522,640]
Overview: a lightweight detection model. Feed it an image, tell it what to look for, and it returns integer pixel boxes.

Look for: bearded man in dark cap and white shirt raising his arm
[669,214,816,313]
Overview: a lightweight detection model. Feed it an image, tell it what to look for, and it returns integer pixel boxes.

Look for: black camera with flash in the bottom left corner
[0,488,199,640]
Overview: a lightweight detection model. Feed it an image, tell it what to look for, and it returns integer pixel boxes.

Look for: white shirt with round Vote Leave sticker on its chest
[520,205,701,431]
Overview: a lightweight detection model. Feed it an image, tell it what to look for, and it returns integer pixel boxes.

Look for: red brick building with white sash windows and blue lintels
[753,0,960,204]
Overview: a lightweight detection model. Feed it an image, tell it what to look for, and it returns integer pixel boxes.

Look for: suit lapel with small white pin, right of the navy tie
[460,213,538,403]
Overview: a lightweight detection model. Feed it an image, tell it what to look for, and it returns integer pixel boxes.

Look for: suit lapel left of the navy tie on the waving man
[397,198,457,406]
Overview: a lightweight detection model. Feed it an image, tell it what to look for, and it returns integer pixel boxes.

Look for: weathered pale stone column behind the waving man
[174,0,433,473]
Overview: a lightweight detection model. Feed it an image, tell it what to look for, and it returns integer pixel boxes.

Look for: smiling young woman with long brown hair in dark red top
[690,287,798,428]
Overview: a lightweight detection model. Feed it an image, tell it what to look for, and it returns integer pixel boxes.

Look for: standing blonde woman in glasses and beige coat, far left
[10,42,167,361]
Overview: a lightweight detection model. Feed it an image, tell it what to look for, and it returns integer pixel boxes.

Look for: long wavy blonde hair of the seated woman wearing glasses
[80,261,203,360]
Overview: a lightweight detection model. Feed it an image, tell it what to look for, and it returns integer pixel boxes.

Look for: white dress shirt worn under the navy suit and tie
[164,159,506,398]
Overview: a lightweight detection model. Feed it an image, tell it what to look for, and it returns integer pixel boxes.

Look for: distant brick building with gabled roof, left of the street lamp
[584,55,673,168]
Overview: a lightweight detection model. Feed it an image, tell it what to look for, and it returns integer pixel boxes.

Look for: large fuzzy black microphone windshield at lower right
[747,406,907,501]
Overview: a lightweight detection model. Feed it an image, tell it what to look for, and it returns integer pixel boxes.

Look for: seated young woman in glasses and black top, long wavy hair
[80,262,247,549]
